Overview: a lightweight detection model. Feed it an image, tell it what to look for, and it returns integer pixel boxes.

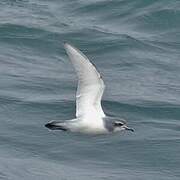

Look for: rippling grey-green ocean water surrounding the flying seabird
[0,0,180,180]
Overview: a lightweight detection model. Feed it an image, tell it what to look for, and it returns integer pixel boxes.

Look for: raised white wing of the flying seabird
[64,43,105,117]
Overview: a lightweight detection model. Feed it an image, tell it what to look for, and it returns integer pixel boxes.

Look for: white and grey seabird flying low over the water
[45,43,134,134]
